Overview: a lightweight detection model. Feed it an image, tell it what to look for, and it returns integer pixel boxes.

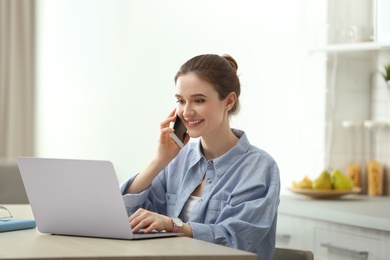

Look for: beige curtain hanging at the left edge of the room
[0,0,35,158]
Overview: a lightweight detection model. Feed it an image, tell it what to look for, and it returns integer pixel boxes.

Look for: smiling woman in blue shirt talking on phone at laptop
[122,54,280,260]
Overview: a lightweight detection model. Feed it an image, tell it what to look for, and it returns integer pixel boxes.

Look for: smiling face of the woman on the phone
[175,73,232,138]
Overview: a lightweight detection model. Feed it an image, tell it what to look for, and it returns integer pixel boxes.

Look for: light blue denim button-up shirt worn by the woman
[121,129,280,260]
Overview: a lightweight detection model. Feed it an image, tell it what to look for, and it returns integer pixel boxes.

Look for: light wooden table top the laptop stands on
[0,205,257,260]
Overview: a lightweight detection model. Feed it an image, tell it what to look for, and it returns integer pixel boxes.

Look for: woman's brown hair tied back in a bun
[175,54,241,114]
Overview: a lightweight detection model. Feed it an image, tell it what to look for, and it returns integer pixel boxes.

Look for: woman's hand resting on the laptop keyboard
[129,208,173,233]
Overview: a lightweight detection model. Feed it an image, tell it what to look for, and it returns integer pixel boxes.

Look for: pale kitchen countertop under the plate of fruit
[279,193,390,231]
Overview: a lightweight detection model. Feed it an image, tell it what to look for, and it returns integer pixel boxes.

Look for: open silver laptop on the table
[17,157,180,239]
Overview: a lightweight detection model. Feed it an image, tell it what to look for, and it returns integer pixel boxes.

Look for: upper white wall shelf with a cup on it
[309,42,390,53]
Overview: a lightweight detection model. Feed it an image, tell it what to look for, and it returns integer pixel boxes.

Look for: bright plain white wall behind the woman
[36,0,326,186]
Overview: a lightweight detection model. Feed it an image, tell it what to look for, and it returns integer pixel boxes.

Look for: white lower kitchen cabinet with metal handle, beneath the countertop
[276,214,390,260]
